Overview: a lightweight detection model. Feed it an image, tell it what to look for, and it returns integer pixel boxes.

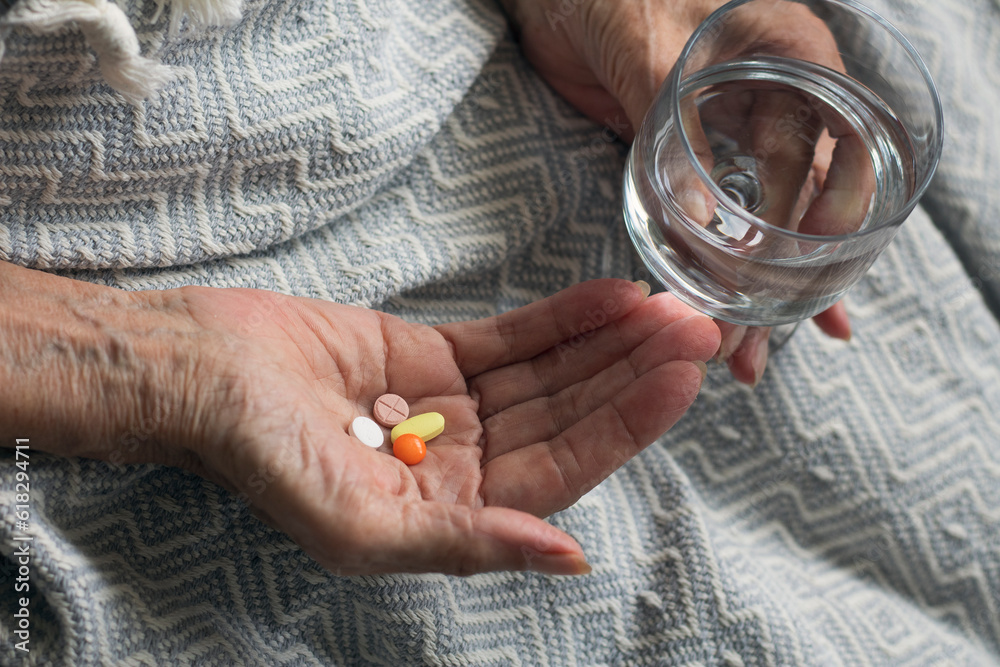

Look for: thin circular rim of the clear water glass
[668,0,944,243]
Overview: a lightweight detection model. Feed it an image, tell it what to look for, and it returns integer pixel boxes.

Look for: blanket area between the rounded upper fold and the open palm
[56,38,630,306]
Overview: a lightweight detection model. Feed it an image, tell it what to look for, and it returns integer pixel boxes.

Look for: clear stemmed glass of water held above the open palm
[624,0,943,326]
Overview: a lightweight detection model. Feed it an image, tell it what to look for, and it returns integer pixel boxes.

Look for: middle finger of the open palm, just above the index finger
[482,316,719,462]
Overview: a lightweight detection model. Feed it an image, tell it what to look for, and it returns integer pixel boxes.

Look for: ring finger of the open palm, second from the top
[469,293,698,419]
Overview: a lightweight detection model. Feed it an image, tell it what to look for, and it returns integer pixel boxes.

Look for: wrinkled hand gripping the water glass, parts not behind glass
[502,0,853,384]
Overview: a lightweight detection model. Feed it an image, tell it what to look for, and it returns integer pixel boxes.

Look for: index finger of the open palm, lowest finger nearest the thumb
[482,361,702,516]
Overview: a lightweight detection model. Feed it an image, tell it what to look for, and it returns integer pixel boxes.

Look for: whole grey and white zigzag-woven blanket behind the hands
[0,0,1000,667]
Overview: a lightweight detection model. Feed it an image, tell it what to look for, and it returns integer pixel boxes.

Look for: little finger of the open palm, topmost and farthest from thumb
[435,279,645,377]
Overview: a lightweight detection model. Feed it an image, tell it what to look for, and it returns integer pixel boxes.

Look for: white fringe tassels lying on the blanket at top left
[0,0,240,104]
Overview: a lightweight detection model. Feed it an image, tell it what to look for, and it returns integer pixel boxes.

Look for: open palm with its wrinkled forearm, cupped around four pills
[0,265,719,574]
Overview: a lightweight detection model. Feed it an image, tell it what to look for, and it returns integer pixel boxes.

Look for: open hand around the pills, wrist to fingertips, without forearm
[174,280,719,574]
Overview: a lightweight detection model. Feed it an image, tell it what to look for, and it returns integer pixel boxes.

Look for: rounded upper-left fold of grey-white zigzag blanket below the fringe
[0,0,504,269]
